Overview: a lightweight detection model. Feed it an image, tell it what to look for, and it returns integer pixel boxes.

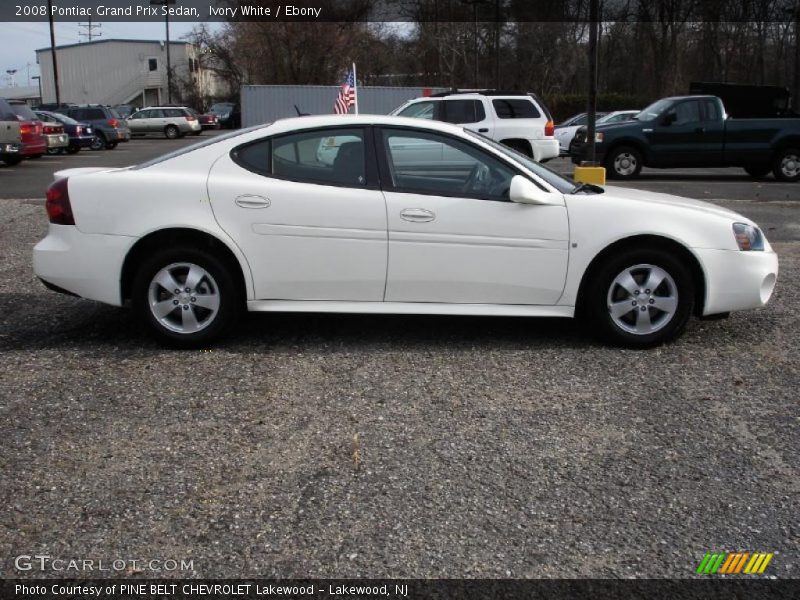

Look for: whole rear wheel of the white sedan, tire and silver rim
[133,247,242,348]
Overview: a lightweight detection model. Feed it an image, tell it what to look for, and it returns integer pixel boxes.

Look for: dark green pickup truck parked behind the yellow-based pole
[570,96,800,181]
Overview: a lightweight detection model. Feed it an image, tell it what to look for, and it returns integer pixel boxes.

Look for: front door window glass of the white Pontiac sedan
[382,129,515,200]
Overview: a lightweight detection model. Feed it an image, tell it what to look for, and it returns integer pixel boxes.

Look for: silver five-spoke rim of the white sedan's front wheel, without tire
[608,264,678,335]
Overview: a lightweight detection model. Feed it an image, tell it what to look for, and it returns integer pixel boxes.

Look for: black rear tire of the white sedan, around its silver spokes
[132,246,244,348]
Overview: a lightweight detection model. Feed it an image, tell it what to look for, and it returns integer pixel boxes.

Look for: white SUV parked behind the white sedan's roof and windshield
[391,91,558,162]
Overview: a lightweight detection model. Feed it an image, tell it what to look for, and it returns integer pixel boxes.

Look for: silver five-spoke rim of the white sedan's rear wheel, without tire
[147,263,220,333]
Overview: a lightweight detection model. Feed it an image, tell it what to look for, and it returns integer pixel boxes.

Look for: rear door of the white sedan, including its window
[208,127,387,302]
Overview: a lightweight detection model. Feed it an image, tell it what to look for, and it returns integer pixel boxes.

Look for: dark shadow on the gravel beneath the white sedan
[0,294,764,354]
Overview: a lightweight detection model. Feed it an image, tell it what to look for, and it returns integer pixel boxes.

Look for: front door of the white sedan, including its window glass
[376,127,569,305]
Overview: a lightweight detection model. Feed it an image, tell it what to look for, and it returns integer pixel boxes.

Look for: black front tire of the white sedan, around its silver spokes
[580,248,694,348]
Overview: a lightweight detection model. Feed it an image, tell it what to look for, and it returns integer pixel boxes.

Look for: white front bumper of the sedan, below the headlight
[694,248,778,315]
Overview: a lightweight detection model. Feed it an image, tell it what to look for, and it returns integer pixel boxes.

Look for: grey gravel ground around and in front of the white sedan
[0,200,800,578]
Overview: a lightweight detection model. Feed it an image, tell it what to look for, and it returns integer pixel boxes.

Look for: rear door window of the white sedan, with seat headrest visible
[272,129,367,187]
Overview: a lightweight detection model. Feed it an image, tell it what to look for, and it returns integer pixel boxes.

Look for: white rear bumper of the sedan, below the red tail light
[33,223,136,306]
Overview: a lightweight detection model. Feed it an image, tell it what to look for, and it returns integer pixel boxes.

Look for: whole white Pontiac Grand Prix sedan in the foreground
[33,115,778,347]
